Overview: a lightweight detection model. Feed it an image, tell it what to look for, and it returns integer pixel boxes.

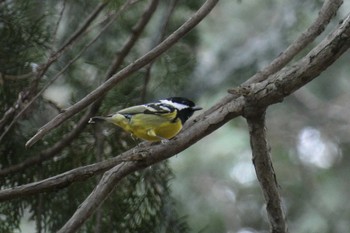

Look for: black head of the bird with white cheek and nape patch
[160,97,202,124]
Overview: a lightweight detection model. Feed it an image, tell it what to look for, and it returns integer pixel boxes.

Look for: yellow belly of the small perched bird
[111,112,182,142]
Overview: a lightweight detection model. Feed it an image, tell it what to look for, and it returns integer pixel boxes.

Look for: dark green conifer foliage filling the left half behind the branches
[0,1,197,233]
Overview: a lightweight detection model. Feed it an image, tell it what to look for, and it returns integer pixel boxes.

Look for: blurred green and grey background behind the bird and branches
[0,0,350,233]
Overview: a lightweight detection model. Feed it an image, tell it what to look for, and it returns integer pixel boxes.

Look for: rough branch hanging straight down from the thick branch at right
[245,109,288,233]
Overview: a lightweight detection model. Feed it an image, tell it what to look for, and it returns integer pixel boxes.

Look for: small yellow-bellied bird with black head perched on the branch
[89,97,202,142]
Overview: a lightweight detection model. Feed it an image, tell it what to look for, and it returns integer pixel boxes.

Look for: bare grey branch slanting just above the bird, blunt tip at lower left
[26,0,218,147]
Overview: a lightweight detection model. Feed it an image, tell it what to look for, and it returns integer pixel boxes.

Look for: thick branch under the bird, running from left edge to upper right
[0,12,350,200]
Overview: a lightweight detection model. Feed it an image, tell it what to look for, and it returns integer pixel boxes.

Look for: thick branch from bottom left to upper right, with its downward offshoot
[10,13,350,232]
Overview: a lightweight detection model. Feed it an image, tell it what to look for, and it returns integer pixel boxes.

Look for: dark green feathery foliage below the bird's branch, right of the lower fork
[80,163,188,232]
